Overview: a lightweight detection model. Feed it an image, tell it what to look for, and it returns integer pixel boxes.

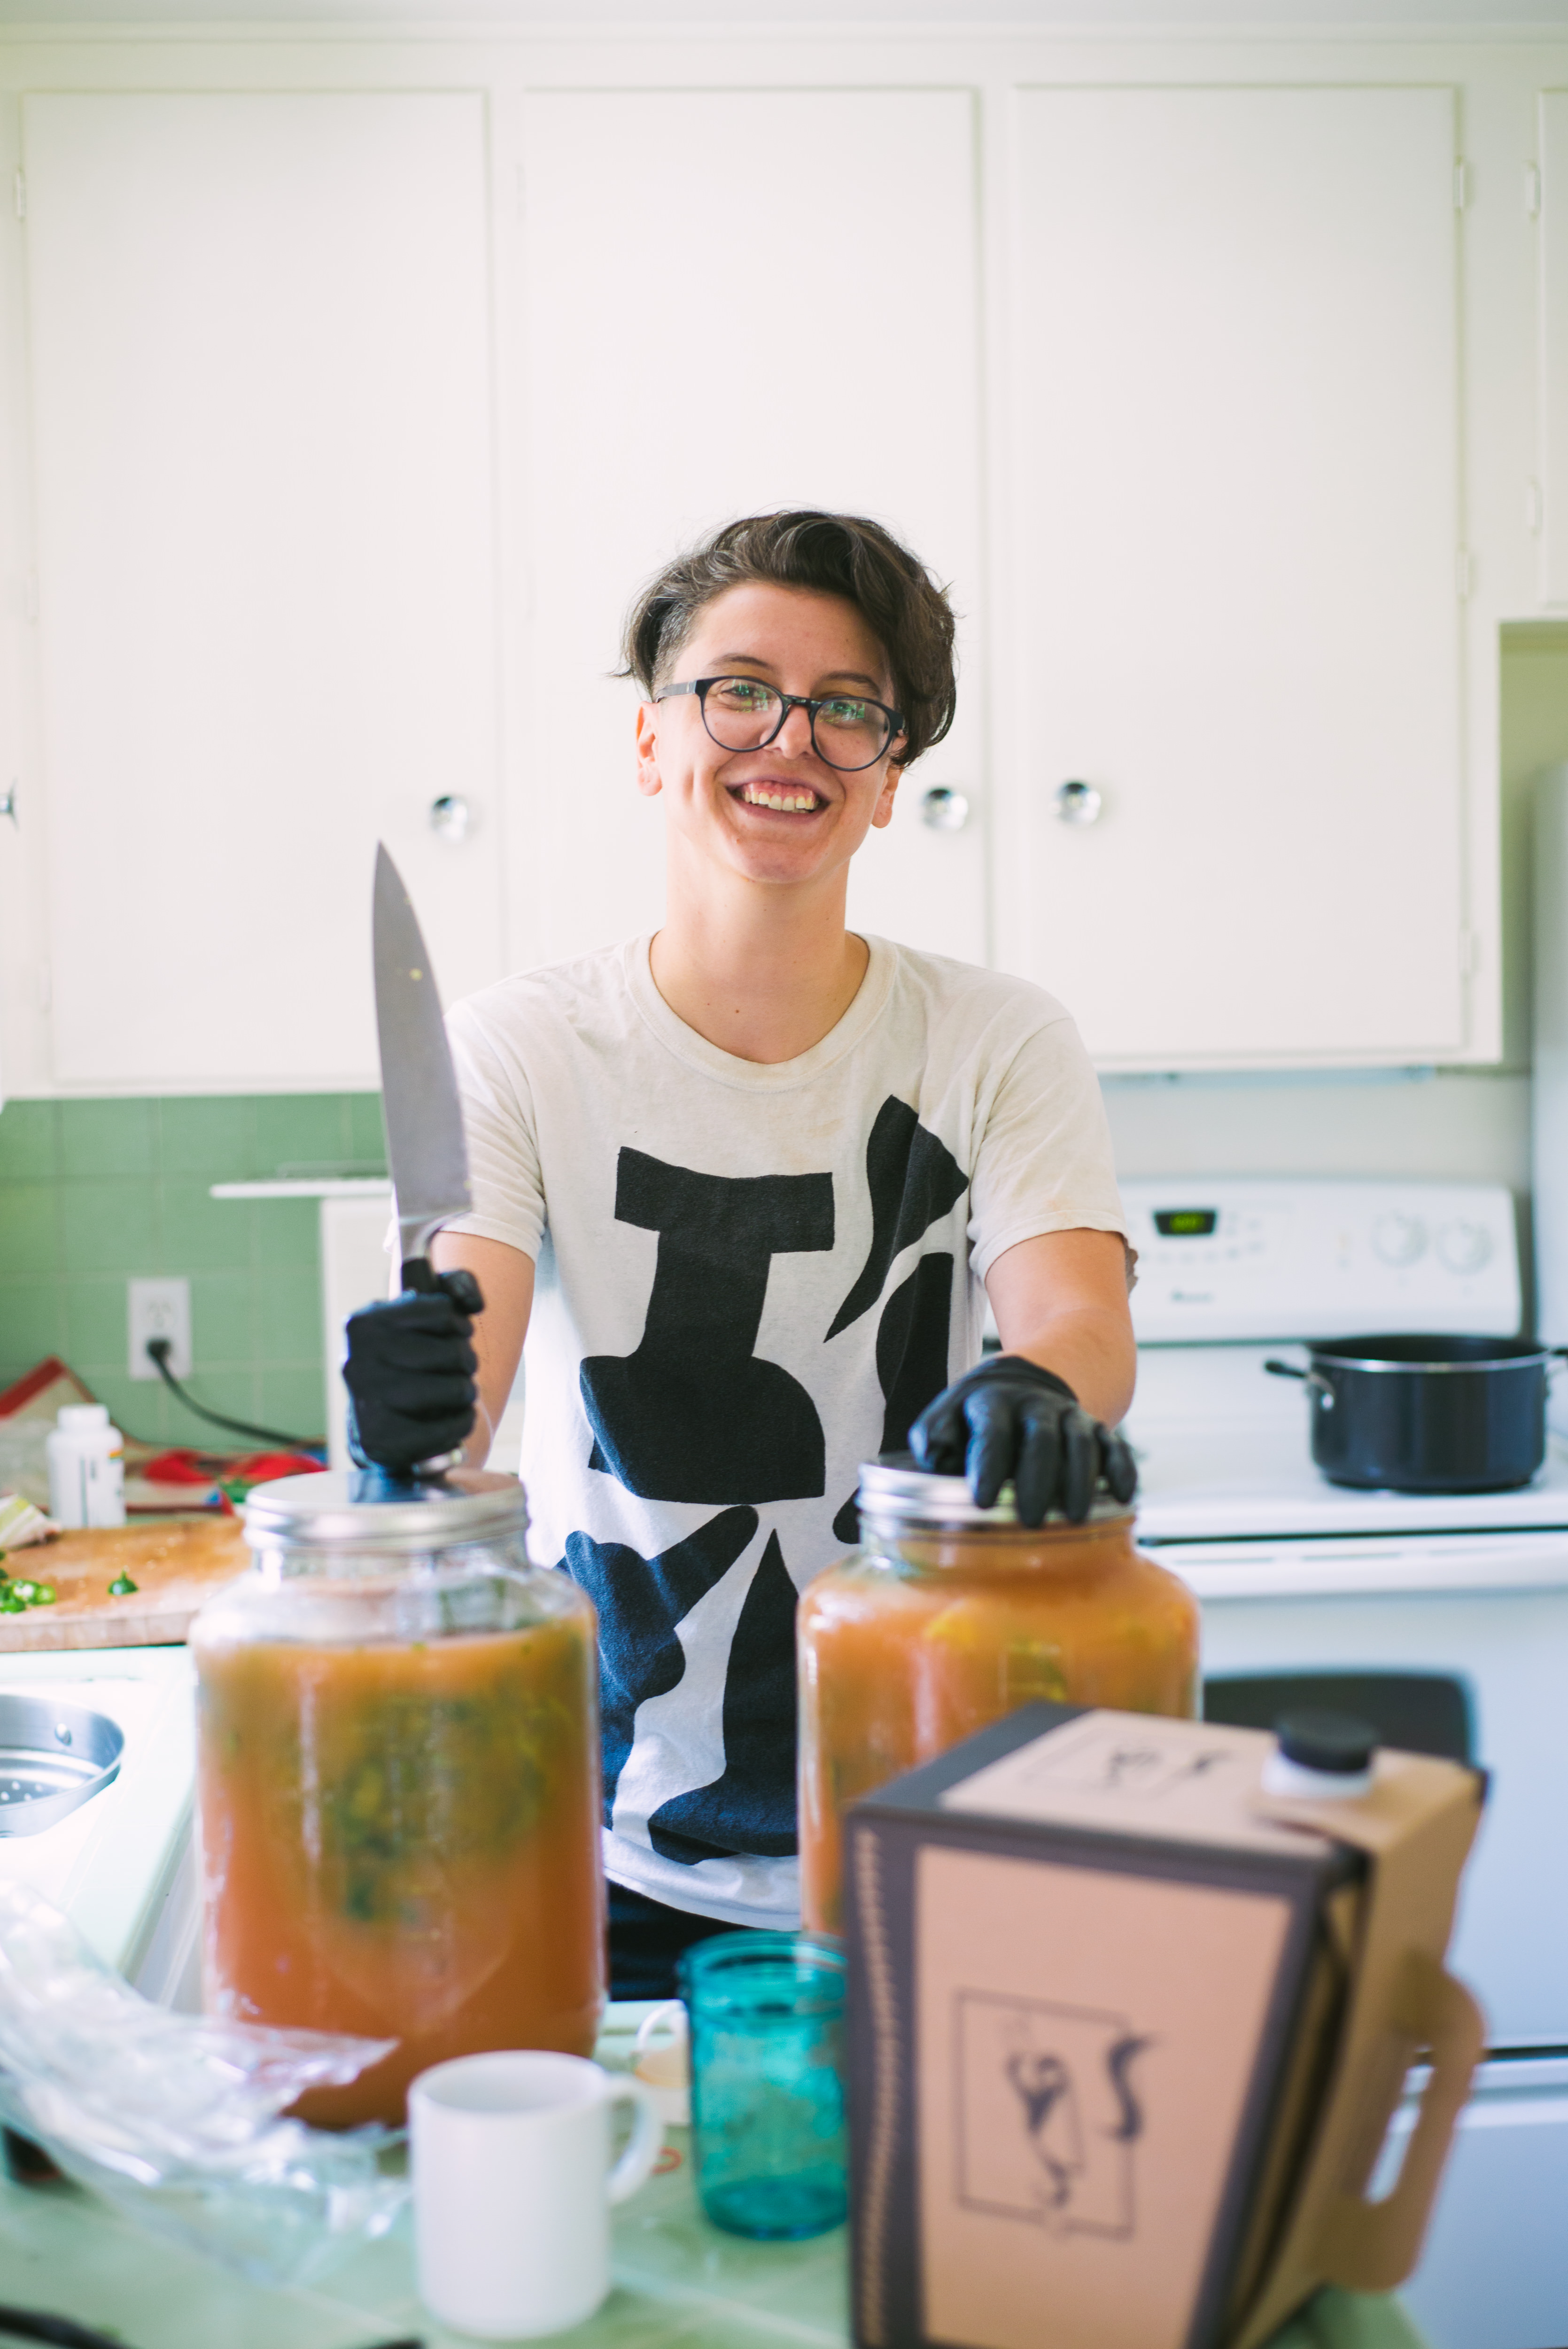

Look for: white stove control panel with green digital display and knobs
[1122,1174,1521,1346]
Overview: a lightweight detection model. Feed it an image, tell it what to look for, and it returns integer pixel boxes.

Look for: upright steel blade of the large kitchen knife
[371,841,472,1290]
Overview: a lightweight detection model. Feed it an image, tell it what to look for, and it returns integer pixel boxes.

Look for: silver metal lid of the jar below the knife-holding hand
[244,1468,528,1553]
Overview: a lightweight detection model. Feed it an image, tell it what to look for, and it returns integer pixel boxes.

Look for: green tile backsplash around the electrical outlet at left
[0,1092,385,1445]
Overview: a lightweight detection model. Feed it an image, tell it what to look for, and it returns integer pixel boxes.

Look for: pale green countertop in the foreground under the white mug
[0,2006,1422,2349]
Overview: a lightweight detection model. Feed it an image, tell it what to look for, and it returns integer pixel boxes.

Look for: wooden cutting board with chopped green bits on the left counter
[0,1513,251,1658]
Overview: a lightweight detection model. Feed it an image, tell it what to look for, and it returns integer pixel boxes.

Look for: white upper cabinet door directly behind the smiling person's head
[509,89,986,963]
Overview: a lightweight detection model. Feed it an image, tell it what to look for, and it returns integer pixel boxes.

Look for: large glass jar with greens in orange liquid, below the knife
[190,1470,605,2126]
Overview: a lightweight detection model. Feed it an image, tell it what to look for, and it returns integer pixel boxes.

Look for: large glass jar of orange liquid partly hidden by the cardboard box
[796,1461,1197,1933]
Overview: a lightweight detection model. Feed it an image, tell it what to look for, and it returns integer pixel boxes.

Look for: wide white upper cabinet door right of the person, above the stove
[998,89,1465,1069]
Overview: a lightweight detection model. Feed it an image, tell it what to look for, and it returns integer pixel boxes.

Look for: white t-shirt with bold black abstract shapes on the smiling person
[448,937,1122,1924]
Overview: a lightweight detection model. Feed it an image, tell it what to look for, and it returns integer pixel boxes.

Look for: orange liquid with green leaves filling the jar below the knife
[197,1621,603,2128]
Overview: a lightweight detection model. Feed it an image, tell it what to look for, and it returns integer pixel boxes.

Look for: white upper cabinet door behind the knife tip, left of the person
[26,94,500,1088]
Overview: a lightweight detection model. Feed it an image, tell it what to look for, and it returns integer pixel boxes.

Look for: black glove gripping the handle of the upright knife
[343,1271,483,1475]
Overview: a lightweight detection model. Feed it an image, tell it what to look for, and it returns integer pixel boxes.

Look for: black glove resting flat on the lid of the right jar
[908,1353,1139,1525]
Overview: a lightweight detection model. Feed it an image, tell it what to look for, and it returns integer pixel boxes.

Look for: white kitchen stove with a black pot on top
[1122,1177,1568,2349]
